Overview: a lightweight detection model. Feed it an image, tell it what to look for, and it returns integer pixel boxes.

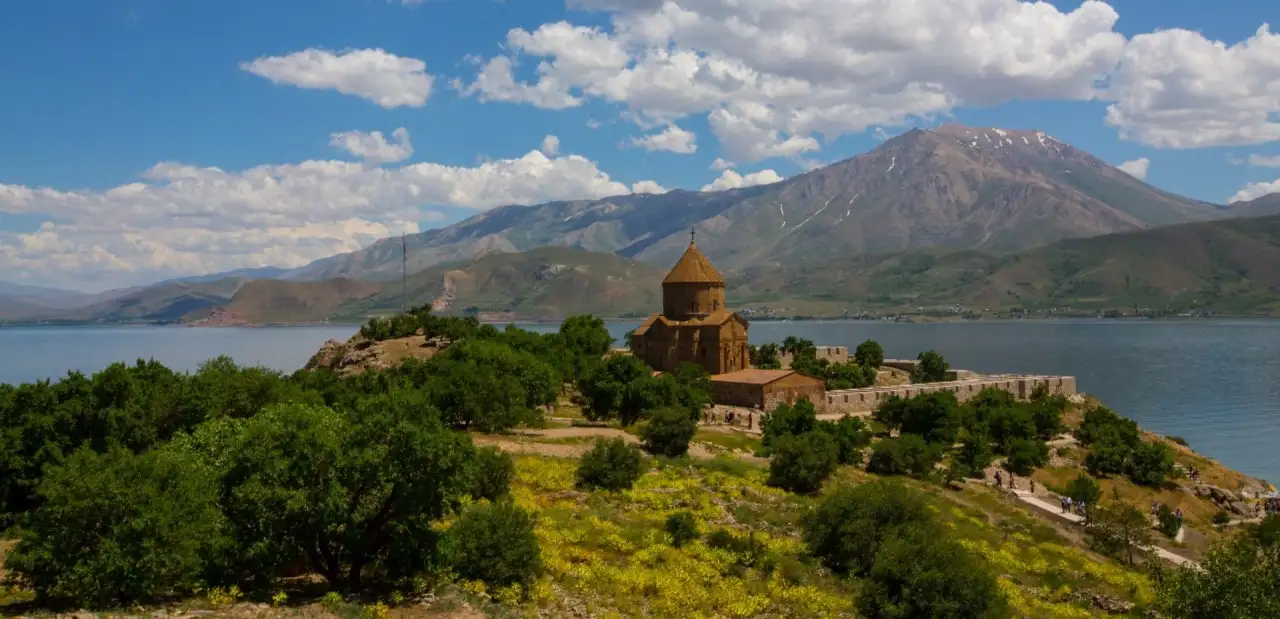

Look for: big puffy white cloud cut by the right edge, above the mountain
[1106,24,1280,148]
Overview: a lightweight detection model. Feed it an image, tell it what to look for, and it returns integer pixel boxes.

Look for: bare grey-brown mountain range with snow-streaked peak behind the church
[283,124,1231,280]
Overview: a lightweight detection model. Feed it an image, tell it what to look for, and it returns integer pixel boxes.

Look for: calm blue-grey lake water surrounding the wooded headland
[0,321,1280,482]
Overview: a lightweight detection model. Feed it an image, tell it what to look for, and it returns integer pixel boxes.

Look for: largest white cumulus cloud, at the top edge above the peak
[457,0,1125,161]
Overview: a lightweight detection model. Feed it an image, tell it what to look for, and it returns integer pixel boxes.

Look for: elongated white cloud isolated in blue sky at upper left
[241,49,434,109]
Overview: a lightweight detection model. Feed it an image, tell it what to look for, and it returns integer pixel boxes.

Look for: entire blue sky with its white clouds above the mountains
[0,0,1280,289]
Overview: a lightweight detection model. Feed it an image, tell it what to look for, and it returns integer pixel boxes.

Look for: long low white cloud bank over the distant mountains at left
[0,140,662,288]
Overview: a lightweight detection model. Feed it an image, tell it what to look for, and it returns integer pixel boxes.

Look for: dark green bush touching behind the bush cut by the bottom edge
[800,480,936,576]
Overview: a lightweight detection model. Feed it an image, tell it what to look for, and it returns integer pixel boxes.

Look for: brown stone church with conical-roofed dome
[631,238,750,375]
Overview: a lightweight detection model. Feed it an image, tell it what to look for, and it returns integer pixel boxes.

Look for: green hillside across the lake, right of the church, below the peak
[731,216,1280,315]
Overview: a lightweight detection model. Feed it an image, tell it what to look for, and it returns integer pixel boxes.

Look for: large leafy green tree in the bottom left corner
[5,448,229,607]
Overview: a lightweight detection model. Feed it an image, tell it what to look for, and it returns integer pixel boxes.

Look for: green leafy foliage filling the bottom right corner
[1156,524,1280,619]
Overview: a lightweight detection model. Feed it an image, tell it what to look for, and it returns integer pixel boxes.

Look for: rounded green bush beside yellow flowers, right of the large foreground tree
[449,501,543,587]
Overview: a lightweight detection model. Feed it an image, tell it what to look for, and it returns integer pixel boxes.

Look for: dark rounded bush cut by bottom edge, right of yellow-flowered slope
[858,529,1009,619]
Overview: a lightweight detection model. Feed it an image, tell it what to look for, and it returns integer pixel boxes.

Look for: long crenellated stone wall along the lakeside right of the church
[824,375,1076,413]
